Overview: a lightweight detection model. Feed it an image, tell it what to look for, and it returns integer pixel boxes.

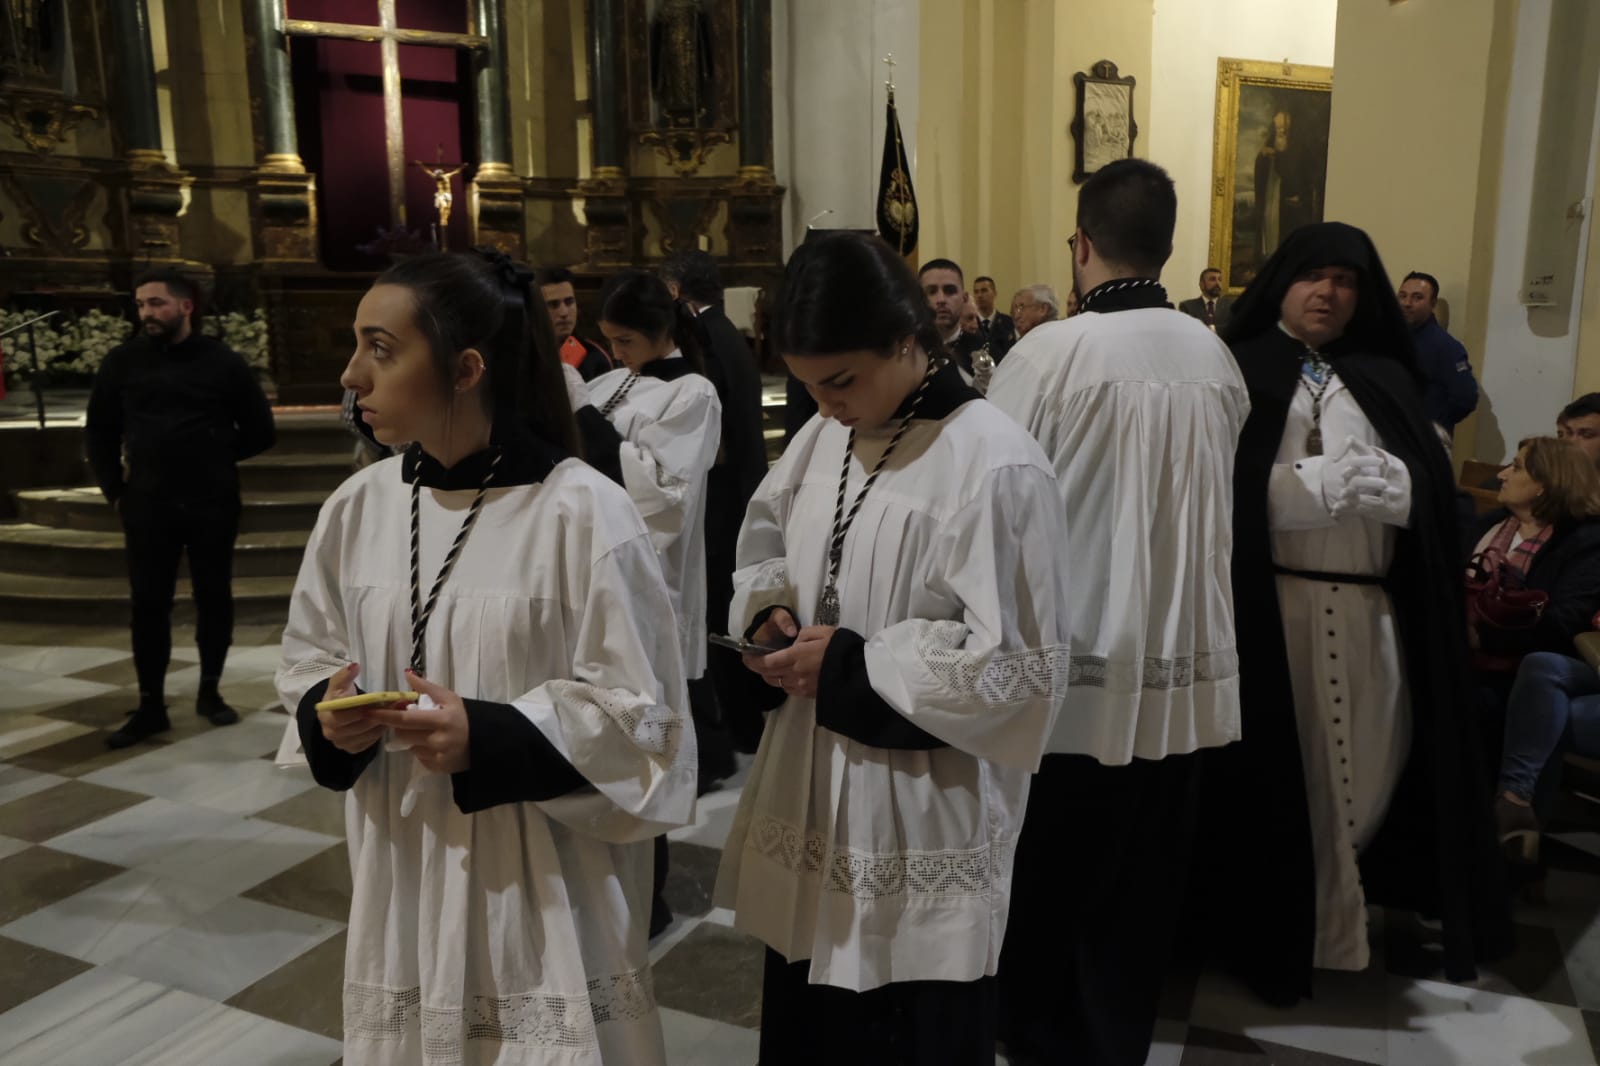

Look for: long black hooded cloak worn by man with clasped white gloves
[1198,222,1510,1002]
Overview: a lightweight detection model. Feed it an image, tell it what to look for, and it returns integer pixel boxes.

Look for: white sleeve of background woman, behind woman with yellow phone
[618,383,722,551]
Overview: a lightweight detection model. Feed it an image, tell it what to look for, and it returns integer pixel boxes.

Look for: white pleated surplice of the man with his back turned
[989,307,1250,765]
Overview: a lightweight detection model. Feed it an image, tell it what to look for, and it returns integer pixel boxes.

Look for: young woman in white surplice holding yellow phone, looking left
[278,254,694,1066]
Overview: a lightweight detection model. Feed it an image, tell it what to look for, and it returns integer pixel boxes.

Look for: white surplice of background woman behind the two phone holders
[589,355,722,680]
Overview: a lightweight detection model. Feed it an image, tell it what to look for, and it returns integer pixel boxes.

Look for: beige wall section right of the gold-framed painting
[1326,0,1515,456]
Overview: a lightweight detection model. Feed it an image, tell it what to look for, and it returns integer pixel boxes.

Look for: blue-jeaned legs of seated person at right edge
[1494,651,1600,863]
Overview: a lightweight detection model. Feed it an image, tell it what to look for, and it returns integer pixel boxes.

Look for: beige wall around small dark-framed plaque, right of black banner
[914,0,1152,303]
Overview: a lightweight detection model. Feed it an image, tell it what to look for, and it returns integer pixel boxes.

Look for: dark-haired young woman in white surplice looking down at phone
[717,234,1067,1066]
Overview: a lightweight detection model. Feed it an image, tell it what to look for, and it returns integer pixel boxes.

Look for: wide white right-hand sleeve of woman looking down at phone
[866,466,1069,770]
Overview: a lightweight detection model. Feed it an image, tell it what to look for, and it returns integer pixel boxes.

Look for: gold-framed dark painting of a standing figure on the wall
[1210,59,1333,293]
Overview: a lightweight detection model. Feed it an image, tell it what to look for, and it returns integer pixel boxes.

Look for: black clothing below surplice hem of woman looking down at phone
[760,949,995,1066]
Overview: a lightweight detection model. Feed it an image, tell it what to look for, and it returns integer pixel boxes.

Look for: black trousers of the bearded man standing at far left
[118,488,238,701]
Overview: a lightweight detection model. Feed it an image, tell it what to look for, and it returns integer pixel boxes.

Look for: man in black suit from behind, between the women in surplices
[661,250,766,765]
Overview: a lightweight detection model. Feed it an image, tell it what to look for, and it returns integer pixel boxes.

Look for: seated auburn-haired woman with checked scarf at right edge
[1467,437,1600,685]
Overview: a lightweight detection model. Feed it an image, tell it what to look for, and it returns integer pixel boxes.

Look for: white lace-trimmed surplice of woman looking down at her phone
[717,400,1067,991]
